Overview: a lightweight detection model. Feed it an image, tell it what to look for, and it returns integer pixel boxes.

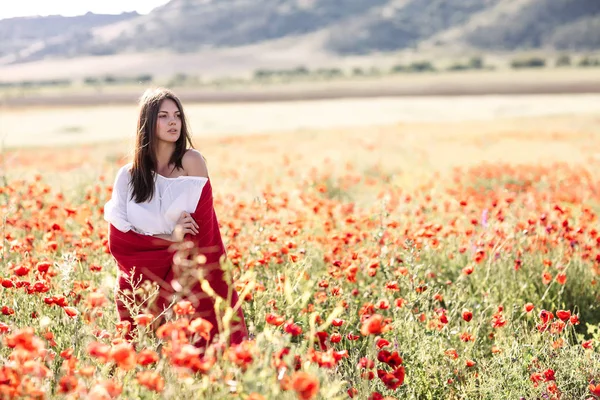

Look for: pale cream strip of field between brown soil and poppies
[0,94,600,148]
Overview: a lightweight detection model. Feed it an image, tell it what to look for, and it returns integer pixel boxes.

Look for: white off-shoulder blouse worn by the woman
[104,163,208,235]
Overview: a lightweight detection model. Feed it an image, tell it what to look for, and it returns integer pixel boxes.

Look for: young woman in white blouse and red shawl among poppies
[104,89,248,346]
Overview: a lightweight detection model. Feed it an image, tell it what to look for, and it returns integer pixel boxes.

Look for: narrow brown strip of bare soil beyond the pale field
[0,68,600,108]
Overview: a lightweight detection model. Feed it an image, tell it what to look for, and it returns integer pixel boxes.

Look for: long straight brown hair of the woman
[131,88,194,203]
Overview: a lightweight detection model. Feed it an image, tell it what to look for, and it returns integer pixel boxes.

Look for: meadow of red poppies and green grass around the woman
[0,104,600,400]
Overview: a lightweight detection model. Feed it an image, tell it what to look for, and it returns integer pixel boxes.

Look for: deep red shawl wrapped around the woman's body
[108,179,248,346]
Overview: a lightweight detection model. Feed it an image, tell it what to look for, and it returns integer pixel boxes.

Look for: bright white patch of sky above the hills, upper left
[0,0,169,19]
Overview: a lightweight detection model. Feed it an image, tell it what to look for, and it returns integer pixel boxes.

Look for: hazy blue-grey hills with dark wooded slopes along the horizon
[0,0,600,64]
